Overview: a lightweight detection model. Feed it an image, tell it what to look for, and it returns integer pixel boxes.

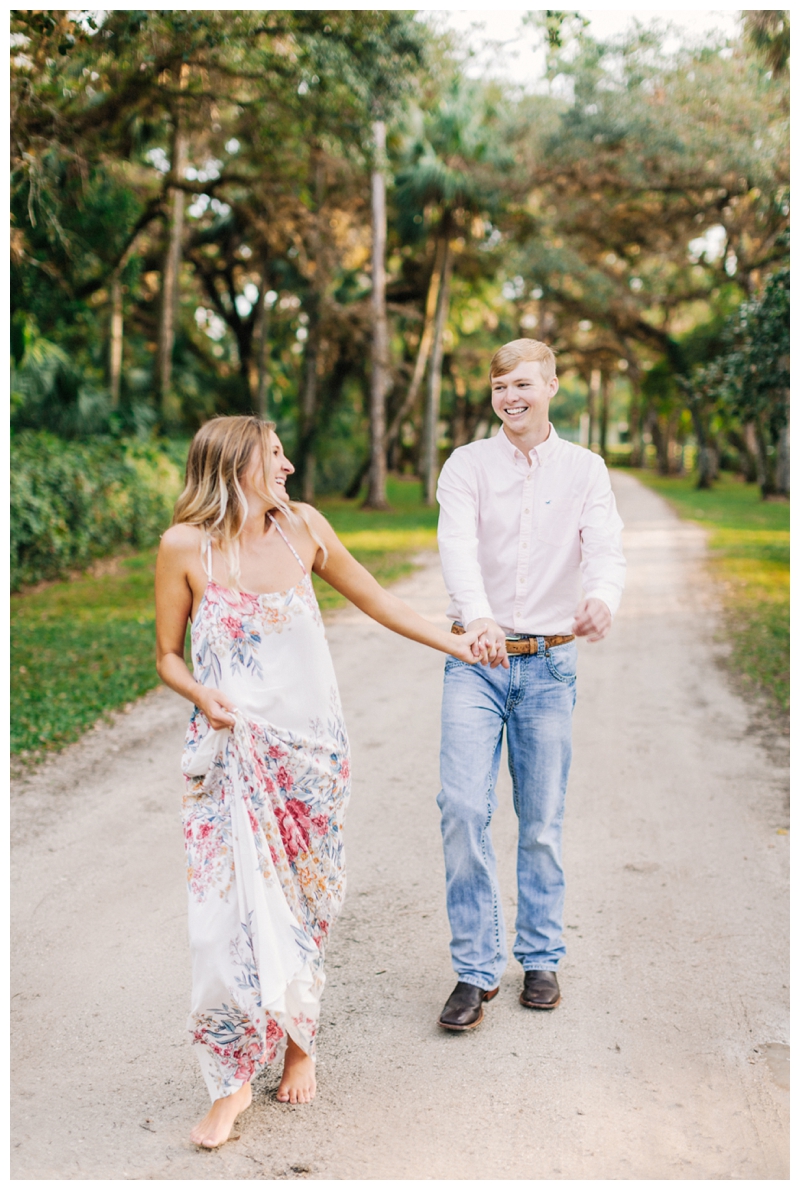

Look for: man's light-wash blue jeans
[437,637,577,991]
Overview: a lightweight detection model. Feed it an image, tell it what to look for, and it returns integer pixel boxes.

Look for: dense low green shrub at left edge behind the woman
[11,431,182,590]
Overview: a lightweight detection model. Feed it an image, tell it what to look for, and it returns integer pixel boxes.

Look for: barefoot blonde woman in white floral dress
[156,417,481,1148]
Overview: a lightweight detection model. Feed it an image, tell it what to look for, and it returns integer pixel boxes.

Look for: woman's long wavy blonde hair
[173,417,327,587]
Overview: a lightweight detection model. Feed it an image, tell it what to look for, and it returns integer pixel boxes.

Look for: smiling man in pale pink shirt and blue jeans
[437,339,625,1031]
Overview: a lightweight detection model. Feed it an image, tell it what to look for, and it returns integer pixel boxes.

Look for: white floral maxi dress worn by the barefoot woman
[181,518,350,1101]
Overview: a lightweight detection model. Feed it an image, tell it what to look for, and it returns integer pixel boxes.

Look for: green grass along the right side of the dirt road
[635,471,789,714]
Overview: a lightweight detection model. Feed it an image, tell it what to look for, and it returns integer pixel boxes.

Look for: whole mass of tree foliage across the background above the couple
[11,10,789,509]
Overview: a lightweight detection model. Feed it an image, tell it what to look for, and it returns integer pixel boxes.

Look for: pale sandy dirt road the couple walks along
[11,475,788,1179]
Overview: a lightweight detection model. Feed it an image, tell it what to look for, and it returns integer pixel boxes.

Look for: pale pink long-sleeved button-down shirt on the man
[437,425,625,637]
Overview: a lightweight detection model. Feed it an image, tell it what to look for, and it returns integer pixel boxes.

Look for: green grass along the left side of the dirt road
[11,480,437,758]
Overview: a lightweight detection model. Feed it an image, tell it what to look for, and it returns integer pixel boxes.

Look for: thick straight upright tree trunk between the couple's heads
[364,120,389,508]
